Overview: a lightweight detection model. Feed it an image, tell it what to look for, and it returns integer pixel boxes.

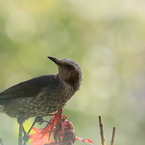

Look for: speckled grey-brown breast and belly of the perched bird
[5,80,75,119]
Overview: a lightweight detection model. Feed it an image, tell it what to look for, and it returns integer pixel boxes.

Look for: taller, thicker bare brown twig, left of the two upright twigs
[99,116,106,145]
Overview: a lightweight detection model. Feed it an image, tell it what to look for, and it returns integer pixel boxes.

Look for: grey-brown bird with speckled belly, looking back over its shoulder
[0,56,82,123]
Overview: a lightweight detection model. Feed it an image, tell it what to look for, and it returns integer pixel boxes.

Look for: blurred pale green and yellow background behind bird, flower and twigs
[0,0,145,145]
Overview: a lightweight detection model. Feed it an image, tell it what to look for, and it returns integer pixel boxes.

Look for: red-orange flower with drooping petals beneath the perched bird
[30,109,93,145]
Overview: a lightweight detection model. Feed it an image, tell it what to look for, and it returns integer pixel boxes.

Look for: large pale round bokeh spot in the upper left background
[6,11,36,42]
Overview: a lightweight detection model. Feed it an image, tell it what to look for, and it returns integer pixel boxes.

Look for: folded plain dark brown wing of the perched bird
[0,75,58,100]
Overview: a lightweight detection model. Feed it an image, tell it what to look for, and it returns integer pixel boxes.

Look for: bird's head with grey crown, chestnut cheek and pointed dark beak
[48,56,82,90]
